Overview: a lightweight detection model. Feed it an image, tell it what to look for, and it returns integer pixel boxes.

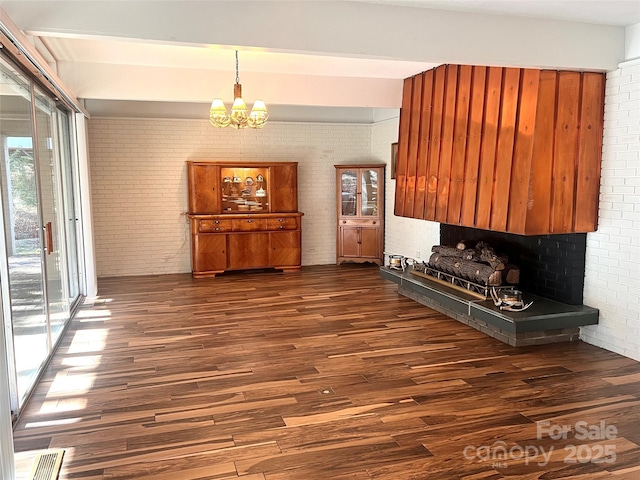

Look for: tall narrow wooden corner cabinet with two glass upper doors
[335,164,385,265]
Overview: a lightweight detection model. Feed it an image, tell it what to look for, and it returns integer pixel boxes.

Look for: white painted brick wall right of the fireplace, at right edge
[580,60,640,360]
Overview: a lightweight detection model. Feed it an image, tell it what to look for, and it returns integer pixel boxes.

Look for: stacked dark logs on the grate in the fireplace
[429,241,520,287]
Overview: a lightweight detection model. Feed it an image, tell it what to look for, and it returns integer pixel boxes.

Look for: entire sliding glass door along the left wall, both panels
[0,51,79,413]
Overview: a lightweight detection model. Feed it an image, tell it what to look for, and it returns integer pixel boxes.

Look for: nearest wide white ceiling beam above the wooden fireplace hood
[3,0,625,73]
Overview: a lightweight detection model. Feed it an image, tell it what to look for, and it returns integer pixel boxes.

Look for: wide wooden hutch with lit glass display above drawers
[187,161,303,278]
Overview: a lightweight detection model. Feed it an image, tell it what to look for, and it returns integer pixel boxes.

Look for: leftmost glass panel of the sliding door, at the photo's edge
[0,55,49,412]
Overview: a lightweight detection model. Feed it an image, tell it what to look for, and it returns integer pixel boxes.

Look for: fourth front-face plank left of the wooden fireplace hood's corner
[460,67,487,227]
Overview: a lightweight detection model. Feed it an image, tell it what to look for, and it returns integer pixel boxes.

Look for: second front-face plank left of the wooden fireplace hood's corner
[490,68,521,232]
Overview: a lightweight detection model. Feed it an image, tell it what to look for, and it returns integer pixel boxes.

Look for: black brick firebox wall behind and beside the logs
[440,224,587,305]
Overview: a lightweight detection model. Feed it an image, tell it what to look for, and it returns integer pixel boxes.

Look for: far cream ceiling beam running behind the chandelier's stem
[58,62,403,108]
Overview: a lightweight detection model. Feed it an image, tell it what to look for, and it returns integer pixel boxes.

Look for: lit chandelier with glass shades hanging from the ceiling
[209,50,269,128]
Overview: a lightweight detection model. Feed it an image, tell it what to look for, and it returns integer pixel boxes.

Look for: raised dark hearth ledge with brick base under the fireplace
[380,267,598,347]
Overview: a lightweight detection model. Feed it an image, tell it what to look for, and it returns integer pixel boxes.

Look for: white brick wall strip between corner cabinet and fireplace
[371,118,440,260]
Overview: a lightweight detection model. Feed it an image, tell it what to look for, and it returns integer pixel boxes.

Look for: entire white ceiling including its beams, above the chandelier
[1,0,640,123]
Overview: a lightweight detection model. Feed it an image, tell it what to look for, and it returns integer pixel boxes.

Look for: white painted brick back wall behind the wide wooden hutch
[89,118,371,277]
